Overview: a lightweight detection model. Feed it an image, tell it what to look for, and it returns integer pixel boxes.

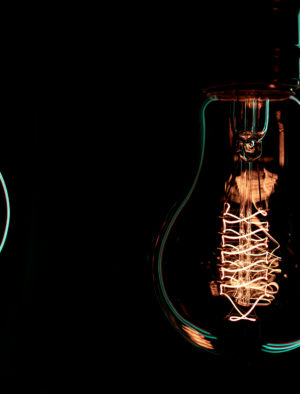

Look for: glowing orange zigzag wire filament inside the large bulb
[220,203,281,321]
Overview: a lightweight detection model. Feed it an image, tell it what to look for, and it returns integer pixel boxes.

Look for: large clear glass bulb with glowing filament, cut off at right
[153,86,300,354]
